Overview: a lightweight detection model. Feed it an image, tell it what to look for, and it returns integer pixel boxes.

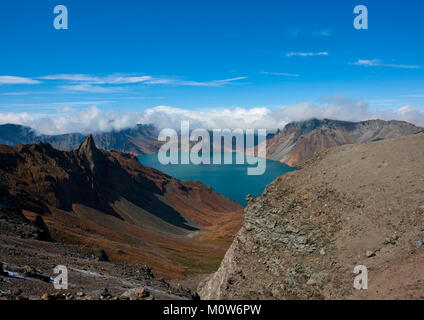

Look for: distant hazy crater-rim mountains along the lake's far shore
[0,119,423,166]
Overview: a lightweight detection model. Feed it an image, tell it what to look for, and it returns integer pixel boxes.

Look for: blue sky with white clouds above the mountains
[0,0,424,134]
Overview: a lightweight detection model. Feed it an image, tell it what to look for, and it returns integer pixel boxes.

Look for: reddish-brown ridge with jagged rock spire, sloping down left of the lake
[0,135,243,278]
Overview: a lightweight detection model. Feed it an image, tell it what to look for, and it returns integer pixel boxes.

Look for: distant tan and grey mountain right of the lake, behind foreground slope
[267,119,422,166]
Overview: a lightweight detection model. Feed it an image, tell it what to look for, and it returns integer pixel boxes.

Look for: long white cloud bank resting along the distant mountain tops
[0,95,424,134]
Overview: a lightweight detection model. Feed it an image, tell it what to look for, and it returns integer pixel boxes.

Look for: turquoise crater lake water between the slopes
[138,153,295,206]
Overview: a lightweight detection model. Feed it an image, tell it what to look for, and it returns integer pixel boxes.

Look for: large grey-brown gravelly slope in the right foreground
[198,133,424,299]
